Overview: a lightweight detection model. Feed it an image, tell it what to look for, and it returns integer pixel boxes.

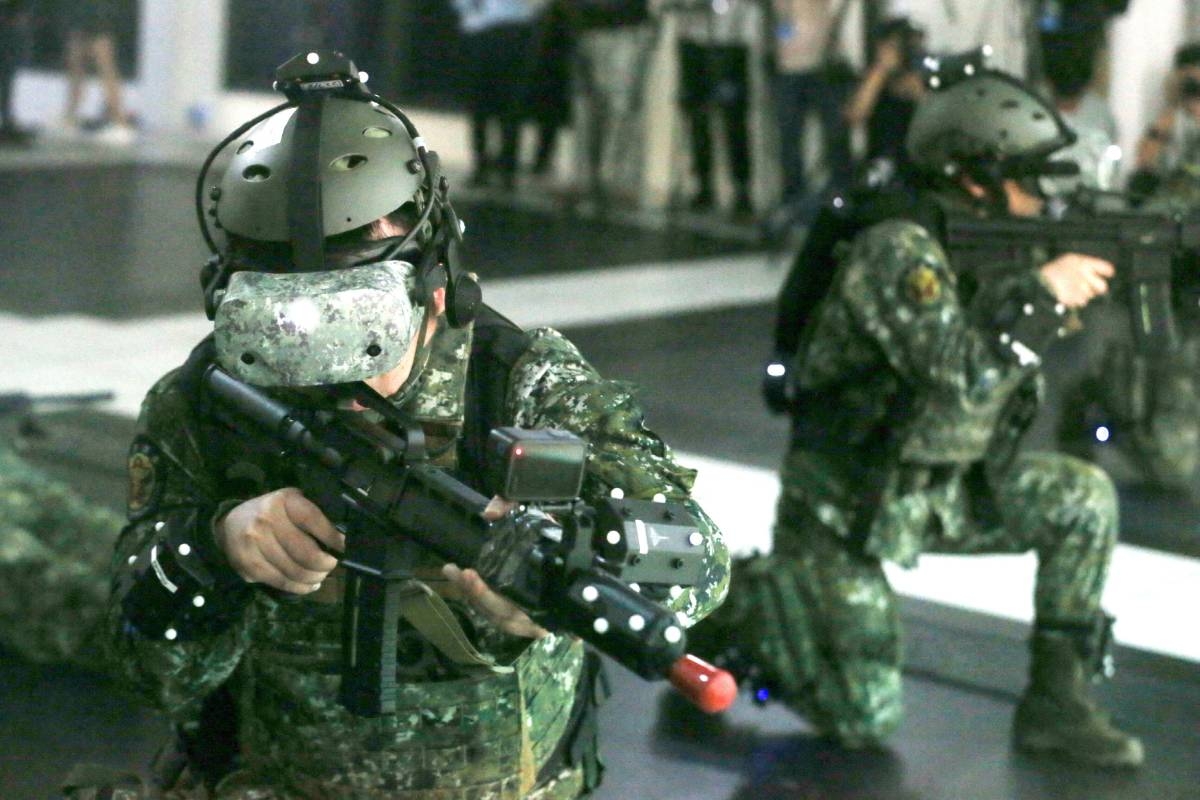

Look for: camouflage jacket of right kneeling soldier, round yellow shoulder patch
[784,219,1061,565]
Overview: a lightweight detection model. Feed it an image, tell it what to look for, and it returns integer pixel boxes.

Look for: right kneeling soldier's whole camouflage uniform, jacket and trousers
[697,219,1117,745]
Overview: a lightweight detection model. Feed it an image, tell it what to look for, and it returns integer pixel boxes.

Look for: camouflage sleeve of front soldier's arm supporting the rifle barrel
[508,329,730,625]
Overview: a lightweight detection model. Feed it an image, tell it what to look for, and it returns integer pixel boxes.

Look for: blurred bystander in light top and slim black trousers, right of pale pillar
[679,0,763,216]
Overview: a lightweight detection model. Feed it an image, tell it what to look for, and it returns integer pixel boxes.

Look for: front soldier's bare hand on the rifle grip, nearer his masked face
[216,488,346,595]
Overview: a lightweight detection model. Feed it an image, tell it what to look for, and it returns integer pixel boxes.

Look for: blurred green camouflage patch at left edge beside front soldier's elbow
[0,444,121,666]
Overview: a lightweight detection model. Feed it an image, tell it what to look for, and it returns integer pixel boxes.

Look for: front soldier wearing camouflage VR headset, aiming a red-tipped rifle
[98,52,727,800]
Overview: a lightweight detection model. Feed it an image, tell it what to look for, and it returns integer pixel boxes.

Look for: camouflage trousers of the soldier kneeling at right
[702,453,1117,746]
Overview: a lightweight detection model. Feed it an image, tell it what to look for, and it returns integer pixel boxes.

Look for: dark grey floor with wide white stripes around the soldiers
[0,140,1200,800]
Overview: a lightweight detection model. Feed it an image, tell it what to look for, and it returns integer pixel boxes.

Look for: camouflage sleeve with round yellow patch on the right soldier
[835,221,1052,402]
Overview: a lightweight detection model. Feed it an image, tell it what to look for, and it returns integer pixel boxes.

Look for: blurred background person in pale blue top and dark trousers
[454,0,534,188]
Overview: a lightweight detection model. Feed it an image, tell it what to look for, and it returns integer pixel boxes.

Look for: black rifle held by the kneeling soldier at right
[943,205,1200,356]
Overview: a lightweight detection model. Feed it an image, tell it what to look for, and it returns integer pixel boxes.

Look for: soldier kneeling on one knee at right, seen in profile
[691,65,1142,766]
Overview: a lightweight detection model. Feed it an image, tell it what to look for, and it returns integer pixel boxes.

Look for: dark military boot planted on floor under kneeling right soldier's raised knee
[1013,631,1144,768]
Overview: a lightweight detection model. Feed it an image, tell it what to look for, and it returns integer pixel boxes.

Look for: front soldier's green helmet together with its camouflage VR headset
[196,50,481,386]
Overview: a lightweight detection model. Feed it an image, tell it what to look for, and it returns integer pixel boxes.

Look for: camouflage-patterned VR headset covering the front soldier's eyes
[214,261,424,386]
